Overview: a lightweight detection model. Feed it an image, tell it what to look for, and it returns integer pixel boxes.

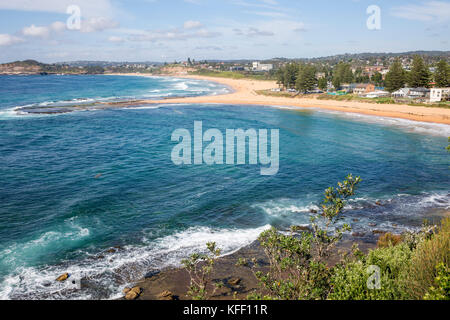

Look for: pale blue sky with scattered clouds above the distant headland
[0,0,450,63]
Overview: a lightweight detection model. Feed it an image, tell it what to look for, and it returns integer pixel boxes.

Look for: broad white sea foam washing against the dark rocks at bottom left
[0,225,270,299]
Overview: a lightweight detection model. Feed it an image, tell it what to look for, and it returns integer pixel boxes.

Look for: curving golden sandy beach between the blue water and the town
[110,74,450,124]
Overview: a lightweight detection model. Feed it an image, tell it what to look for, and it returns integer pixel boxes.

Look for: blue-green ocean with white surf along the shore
[0,76,450,299]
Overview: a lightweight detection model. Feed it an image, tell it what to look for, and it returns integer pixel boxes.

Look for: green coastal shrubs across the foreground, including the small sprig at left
[184,175,450,300]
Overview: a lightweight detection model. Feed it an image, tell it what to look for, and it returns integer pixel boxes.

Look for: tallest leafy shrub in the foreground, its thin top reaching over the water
[240,175,361,300]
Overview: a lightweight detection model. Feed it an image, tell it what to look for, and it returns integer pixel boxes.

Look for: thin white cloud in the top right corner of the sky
[391,1,450,22]
